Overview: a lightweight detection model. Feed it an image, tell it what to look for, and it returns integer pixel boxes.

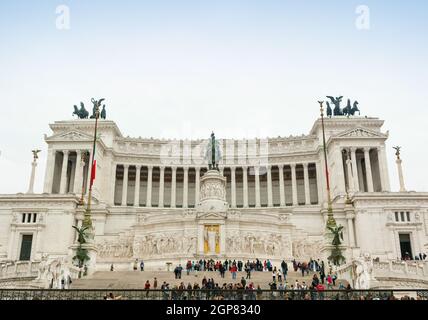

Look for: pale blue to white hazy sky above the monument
[0,0,428,194]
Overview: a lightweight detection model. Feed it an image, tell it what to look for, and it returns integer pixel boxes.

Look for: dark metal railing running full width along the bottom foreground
[0,289,428,300]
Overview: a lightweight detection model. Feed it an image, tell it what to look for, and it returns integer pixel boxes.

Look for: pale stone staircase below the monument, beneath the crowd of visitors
[71,270,332,289]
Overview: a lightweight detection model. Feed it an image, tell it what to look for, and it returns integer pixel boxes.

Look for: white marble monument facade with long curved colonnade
[0,105,428,278]
